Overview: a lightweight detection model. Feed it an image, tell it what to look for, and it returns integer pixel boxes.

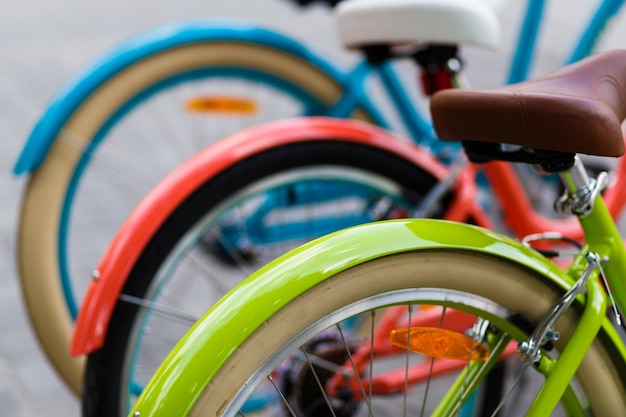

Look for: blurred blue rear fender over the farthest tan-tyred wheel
[13,19,345,175]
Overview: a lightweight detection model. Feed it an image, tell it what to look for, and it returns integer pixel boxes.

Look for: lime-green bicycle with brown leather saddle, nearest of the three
[131,51,626,417]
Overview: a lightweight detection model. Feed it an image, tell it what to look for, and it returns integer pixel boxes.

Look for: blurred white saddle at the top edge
[335,0,500,48]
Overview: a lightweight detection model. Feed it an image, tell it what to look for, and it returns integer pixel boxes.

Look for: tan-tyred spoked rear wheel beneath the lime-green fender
[188,249,626,416]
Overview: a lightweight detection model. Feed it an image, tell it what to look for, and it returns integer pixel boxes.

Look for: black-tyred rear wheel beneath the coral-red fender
[83,140,448,416]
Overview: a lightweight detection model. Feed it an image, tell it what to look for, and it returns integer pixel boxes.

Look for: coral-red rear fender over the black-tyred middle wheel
[70,117,447,356]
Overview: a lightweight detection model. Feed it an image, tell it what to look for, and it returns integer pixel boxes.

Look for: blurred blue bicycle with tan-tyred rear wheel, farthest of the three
[14,0,623,392]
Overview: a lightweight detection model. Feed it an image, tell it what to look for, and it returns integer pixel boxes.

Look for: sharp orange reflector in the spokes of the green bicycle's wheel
[389,327,489,361]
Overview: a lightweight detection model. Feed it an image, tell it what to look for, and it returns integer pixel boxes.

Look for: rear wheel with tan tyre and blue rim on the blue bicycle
[17,34,360,392]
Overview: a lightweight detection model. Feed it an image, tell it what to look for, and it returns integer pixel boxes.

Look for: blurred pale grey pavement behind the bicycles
[0,0,626,417]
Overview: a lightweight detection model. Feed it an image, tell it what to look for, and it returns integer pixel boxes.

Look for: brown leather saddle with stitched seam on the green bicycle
[431,50,626,163]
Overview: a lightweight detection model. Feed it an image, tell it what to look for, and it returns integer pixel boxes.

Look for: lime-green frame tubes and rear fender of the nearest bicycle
[127,195,626,416]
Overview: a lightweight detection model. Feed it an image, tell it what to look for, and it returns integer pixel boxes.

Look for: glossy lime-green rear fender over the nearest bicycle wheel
[130,219,626,417]
